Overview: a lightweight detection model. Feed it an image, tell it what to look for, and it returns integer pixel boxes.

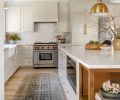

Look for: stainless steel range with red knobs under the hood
[33,42,58,68]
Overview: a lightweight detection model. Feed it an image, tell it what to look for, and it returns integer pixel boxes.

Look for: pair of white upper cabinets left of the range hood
[6,5,33,32]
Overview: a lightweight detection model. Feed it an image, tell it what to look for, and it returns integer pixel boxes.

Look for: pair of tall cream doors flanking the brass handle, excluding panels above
[72,12,98,45]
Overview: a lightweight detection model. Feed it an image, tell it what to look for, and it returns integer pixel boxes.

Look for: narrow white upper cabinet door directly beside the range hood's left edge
[21,5,33,31]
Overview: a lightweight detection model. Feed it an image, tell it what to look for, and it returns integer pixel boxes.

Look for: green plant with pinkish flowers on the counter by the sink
[6,33,21,43]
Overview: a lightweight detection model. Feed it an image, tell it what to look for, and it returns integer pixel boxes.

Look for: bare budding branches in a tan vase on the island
[101,16,120,50]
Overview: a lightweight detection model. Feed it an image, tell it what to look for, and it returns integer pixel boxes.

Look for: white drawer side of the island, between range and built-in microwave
[58,48,78,100]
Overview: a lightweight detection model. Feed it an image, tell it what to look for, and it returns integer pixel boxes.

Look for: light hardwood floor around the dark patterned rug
[5,68,57,100]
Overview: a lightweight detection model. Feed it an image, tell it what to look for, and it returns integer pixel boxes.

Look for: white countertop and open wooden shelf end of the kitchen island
[59,45,120,100]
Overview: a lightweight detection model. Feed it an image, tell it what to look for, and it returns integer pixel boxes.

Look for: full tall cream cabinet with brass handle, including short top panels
[71,3,98,45]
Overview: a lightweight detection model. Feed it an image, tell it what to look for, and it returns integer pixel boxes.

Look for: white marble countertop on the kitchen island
[59,45,120,69]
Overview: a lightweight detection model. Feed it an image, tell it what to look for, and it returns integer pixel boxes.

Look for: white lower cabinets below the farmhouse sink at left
[4,46,21,82]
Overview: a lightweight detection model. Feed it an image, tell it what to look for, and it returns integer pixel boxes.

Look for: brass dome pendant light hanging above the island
[91,0,109,16]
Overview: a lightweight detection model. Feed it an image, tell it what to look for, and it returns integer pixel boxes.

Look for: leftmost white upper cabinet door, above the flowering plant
[6,5,20,32]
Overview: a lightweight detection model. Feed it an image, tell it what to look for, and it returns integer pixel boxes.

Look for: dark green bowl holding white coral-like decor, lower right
[99,87,120,100]
